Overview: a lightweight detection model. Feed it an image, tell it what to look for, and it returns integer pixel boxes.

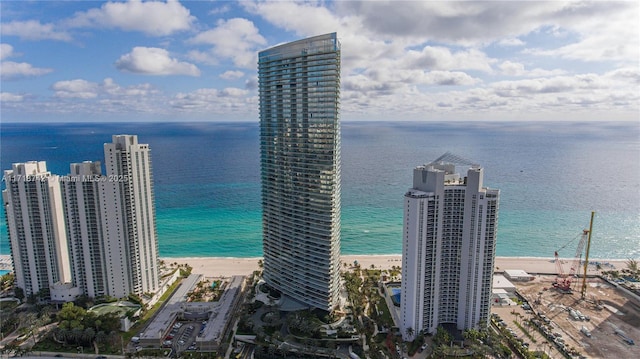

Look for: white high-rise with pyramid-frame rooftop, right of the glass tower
[400,153,500,340]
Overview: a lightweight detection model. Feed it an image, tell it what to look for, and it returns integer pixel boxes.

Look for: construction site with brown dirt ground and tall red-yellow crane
[492,214,640,358]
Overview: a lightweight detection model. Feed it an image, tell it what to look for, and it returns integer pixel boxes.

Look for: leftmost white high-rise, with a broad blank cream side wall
[2,161,73,300]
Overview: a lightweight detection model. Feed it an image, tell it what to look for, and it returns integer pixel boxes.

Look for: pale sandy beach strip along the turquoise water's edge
[162,254,626,277]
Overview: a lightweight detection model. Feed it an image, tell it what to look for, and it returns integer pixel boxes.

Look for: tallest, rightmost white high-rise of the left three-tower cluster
[100,135,160,297]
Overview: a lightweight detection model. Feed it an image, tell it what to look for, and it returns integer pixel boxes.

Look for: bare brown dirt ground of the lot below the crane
[514,275,640,359]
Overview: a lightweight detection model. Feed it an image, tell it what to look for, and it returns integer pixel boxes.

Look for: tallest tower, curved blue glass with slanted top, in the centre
[258,33,340,311]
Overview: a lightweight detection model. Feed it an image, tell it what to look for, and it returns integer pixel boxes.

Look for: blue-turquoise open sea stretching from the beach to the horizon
[0,122,640,259]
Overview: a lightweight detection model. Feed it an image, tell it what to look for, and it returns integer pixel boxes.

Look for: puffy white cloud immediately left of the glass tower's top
[189,18,266,68]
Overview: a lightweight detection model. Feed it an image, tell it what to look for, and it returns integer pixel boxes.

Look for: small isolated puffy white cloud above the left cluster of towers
[116,47,200,76]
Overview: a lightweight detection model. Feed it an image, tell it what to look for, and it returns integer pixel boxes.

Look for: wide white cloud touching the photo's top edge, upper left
[68,0,195,36]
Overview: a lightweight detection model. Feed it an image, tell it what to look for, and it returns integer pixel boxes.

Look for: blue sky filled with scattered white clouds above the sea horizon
[0,0,640,122]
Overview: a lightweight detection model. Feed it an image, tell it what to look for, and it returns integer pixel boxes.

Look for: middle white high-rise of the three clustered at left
[61,161,109,298]
